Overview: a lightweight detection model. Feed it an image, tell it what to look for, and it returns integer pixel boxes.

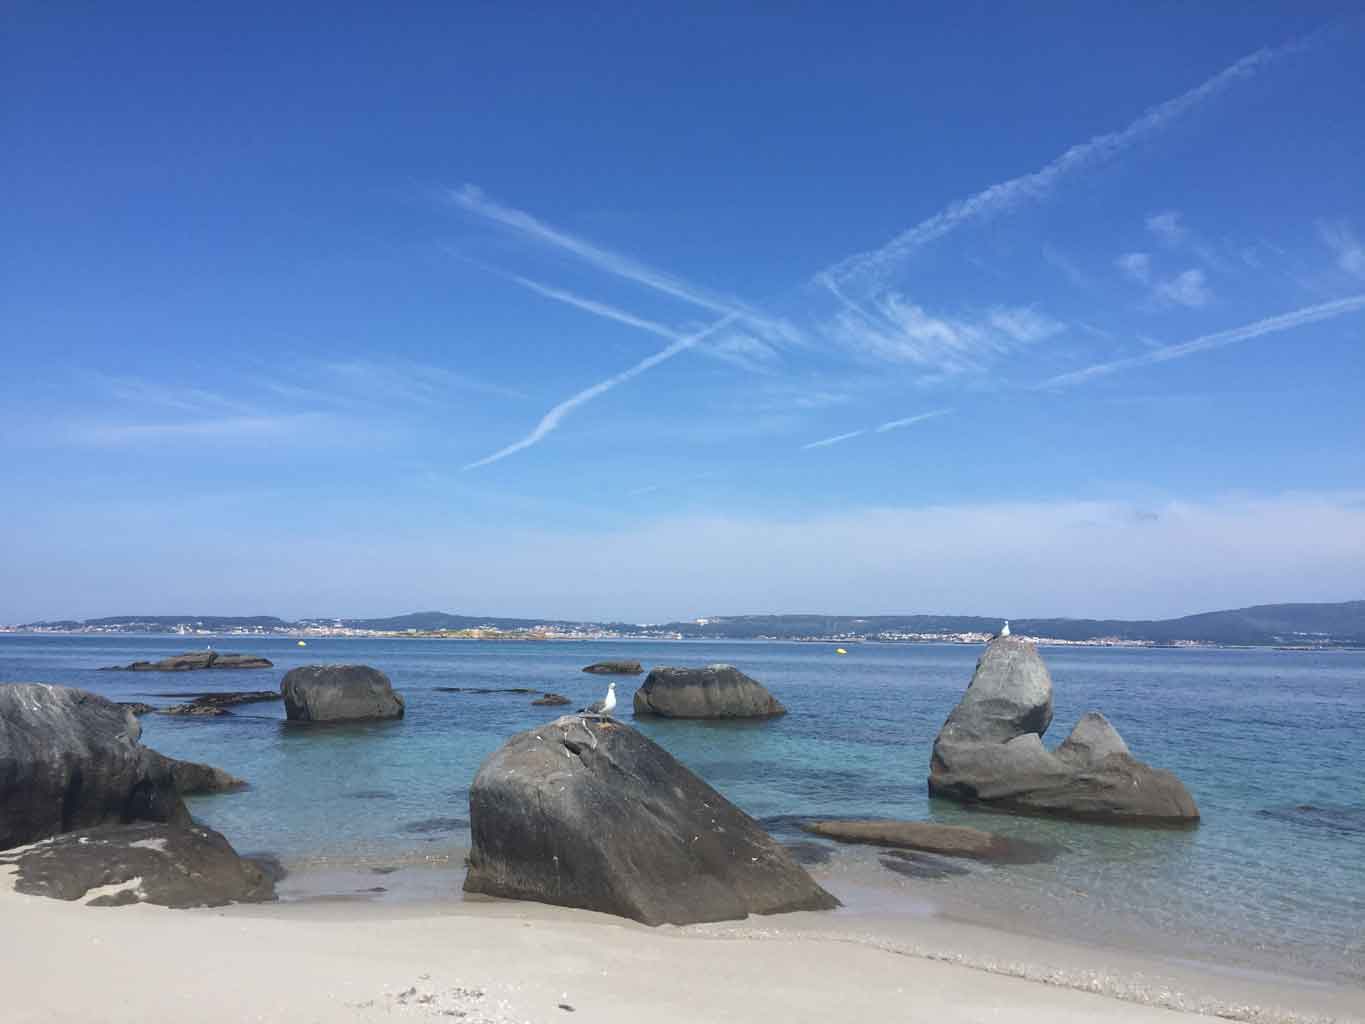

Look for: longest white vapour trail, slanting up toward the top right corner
[816,44,1295,284]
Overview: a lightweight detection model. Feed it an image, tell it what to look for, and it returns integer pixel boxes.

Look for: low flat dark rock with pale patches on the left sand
[0,823,274,907]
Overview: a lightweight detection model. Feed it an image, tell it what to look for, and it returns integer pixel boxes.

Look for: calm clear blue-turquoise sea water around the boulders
[0,635,1365,982]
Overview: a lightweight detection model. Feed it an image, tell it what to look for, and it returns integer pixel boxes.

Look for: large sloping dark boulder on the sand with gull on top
[464,715,838,924]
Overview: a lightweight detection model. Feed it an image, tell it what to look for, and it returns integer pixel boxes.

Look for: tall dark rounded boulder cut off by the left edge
[0,683,190,849]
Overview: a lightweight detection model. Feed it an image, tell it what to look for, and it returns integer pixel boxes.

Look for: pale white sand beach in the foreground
[0,878,1365,1024]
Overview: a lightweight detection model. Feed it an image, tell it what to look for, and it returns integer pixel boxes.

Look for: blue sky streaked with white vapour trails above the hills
[0,4,1365,621]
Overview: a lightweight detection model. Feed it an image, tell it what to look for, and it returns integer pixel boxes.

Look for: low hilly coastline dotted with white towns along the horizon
[13,601,1365,646]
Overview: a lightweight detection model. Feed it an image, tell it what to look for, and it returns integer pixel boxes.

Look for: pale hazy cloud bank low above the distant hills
[37,492,1365,623]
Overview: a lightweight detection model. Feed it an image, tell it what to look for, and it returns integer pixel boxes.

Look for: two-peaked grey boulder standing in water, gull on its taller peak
[928,636,1198,826]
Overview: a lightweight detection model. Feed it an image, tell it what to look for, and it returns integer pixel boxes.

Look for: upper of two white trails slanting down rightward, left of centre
[450,184,797,341]
